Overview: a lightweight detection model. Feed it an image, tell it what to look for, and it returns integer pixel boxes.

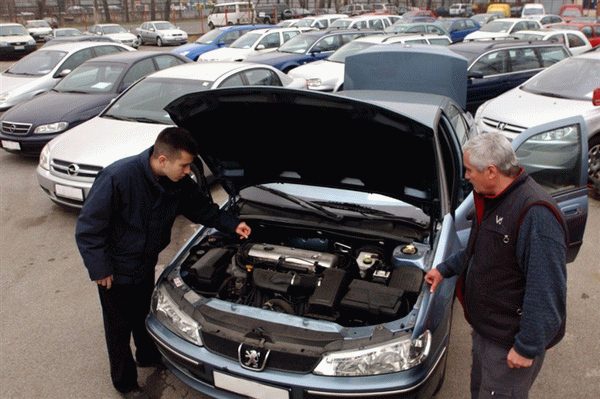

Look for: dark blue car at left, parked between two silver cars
[0,51,192,156]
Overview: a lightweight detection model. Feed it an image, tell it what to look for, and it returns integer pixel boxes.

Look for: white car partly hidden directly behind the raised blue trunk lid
[288,34,452,92]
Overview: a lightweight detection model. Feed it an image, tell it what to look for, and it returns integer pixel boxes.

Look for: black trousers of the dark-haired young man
[98,278,161,393]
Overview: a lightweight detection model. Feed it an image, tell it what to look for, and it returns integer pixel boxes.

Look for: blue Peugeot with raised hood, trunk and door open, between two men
[146,46,587,399]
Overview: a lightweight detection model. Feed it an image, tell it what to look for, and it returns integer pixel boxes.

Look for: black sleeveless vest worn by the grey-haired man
[464,172,566,348]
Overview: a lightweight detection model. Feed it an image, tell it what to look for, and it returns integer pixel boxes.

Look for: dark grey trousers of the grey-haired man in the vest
[471,331,545,399]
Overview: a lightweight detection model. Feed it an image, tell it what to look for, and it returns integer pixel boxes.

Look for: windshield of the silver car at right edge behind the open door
[521,57,600,101]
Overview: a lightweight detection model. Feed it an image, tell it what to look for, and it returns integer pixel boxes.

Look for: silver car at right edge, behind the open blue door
[475,51,600,181]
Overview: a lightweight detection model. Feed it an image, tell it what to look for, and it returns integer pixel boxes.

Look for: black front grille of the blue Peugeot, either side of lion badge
[202,332,320,374]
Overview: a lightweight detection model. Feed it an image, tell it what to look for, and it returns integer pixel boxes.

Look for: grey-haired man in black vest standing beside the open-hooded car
[425,133,567,399]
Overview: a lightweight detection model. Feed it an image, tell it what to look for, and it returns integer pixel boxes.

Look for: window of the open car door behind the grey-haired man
[516,125,582,194]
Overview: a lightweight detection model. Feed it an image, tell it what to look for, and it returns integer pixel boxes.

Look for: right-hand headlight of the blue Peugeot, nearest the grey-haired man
[314,330,431,377]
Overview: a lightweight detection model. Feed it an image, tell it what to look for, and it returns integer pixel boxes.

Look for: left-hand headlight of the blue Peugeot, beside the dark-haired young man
[154,286,203,346]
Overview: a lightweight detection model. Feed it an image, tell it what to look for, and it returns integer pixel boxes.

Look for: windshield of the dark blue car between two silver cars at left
[54,63,125,93]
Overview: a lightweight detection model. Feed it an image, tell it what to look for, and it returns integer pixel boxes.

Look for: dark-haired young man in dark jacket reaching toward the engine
[75,127,251,398]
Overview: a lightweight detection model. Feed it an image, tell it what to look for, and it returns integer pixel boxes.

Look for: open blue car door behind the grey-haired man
[512,116,588,262]
